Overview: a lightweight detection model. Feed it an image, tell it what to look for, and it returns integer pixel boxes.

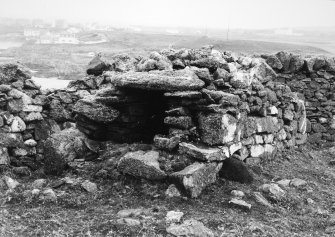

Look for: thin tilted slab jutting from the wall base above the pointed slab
[179,142,227,161]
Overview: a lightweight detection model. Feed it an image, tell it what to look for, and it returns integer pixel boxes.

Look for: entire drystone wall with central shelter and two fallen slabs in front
[0,47,335,197]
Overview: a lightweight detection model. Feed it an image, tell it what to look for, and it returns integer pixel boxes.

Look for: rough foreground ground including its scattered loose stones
[0,143,335,236]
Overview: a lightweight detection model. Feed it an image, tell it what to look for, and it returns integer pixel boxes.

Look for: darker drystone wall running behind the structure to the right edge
[264,52,335,144]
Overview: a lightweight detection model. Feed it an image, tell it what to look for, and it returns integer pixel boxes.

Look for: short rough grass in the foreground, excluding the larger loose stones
[0,143,335,237]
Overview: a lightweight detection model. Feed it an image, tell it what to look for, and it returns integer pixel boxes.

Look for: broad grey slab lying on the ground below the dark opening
[117,151,166,180]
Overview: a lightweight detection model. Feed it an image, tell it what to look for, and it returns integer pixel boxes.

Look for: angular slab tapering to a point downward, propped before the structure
[170,162,222,198]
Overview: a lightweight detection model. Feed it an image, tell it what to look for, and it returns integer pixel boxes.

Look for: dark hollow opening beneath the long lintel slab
[77,89,168,143]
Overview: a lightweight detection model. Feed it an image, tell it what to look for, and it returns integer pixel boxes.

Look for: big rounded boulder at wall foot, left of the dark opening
[44,128,91,175]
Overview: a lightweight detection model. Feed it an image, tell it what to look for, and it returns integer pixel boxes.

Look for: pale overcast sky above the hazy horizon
[0,0,335,29]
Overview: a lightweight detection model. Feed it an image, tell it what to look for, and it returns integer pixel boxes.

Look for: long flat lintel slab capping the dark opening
[106,69,205,91]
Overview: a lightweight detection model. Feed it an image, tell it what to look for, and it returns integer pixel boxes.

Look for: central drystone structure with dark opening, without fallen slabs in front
[74,48,307,168]
